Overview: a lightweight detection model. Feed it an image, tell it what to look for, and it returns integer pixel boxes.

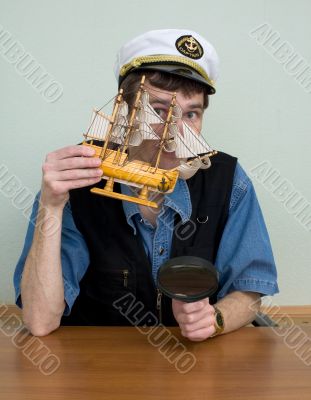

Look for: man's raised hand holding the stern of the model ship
[41,145,102,207]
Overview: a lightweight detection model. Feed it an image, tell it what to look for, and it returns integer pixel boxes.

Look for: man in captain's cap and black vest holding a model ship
[15,30,278,341]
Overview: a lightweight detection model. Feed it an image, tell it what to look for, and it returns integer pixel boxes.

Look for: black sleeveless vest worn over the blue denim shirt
[61,153,237,326]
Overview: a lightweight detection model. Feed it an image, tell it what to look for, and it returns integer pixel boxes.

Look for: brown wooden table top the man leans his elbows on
[0,327,311,400]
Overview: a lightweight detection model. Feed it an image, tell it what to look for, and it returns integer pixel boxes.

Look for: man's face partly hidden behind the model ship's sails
[130,81,204,169]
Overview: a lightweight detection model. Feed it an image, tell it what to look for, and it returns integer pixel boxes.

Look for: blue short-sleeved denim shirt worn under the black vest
[14,164,278,315]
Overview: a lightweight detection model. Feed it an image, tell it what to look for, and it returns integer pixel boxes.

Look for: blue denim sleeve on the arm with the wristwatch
[215,164,279,299]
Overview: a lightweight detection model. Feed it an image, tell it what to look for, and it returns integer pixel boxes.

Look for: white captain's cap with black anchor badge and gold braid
[115,29,219,94]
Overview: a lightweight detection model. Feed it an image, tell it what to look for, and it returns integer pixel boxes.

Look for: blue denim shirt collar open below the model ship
[121,179,192,235]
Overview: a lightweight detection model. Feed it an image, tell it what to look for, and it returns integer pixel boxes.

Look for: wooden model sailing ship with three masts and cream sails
[83,76,217,211]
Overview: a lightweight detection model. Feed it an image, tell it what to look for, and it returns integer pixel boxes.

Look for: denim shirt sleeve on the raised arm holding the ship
[13,193,89,315]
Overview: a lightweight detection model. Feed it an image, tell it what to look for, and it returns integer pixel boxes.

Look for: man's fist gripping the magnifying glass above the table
[172,298,216,341]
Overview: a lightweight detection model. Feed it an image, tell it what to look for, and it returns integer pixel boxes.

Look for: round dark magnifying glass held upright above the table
[157,256,218,303]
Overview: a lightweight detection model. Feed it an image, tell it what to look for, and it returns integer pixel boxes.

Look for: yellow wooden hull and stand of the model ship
[83,142,179,207]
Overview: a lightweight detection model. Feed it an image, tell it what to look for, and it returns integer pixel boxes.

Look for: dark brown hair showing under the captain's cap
[120,70,209,108]
